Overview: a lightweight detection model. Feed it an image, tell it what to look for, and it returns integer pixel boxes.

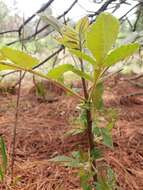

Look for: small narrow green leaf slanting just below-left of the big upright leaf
[69,49,96,66]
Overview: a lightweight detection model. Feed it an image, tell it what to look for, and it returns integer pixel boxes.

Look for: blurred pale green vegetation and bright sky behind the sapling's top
[0,0,143,78]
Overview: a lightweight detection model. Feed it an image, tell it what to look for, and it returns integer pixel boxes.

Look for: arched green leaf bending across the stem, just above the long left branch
[47,64,92,81]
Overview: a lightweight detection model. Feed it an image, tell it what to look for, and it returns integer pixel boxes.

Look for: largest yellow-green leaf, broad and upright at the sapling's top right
[86,13,119,64]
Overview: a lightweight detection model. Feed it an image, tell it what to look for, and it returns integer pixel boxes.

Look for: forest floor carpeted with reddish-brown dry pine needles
[0,77,143,190]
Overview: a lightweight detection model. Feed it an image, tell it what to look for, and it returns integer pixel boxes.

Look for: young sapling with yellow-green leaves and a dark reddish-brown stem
[0,13,139,190]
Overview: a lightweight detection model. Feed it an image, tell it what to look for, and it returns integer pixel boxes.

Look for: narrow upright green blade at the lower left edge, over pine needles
[0,137,7,173]
